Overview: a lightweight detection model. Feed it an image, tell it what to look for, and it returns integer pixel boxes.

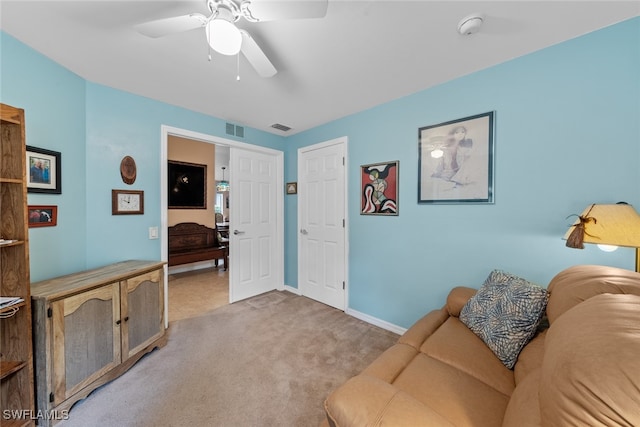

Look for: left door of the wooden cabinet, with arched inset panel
[51,282,120,405]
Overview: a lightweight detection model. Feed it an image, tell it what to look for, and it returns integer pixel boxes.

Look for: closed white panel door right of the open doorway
[298,138,346,310]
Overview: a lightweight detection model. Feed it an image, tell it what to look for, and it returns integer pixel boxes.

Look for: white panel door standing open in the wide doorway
[229,147,279,302]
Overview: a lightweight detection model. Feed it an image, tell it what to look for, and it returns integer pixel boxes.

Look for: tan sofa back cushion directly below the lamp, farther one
[547,265,640,323]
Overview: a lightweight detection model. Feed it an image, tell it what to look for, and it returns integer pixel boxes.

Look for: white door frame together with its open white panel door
[159,125,284,327]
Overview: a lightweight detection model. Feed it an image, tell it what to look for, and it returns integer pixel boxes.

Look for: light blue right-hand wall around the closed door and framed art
[285,18,640,327]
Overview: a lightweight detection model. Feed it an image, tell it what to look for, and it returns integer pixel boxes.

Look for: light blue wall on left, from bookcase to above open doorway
[0,32,284,281]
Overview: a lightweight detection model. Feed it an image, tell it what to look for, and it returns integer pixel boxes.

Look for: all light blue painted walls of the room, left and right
[0,18,640,327]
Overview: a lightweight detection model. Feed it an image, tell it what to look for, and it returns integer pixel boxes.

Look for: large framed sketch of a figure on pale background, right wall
[418,112,494,203]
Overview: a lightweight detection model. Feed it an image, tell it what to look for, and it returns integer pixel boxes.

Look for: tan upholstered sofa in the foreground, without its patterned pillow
[323,266,640,427]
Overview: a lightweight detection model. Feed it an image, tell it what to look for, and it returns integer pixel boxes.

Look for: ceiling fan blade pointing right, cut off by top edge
[240,0,327,22]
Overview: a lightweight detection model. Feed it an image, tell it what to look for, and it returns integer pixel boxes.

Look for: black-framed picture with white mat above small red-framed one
[26,145,62,194]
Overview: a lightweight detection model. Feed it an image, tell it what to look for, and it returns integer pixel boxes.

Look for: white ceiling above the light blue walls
[0,0,640,135]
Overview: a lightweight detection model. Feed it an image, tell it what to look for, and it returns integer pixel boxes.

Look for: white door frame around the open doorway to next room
[160,125,284,328]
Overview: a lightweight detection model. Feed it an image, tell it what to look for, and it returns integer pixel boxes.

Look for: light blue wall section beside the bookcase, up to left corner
[0,32,87,281]
